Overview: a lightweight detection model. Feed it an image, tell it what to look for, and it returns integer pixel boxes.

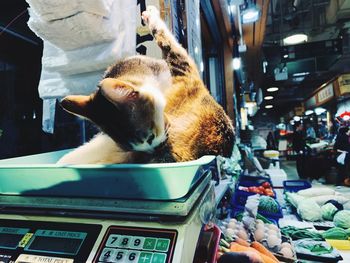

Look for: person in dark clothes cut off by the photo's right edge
[334,126,350,186]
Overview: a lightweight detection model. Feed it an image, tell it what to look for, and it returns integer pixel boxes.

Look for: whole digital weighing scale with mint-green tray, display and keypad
[0,151,220,263]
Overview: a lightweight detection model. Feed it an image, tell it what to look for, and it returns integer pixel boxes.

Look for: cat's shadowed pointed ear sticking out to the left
[60,95,91,118]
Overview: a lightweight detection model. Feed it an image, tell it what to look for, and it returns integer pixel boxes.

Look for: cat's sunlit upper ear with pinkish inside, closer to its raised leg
[99,78,139,104]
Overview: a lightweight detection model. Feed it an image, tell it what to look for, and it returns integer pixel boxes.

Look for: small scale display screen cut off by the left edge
[0,227,29,249]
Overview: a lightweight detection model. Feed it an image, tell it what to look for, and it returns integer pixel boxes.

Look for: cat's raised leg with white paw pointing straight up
[142,6,199,76]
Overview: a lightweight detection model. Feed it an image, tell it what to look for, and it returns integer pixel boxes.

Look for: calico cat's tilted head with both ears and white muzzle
[61,78,166,154]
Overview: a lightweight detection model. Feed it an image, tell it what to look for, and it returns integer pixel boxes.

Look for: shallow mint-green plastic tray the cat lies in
[0,150,215,200]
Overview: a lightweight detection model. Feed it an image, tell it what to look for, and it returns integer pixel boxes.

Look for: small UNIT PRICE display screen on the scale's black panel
[24,229,87,255]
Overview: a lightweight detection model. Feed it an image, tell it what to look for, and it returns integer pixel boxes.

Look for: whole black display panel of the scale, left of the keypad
[0,219,102,263]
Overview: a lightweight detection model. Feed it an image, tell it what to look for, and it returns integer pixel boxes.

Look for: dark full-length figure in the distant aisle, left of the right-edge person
[292,122,306,179]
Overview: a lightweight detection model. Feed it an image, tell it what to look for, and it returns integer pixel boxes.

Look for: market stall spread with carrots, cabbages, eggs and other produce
[217,156,350,262]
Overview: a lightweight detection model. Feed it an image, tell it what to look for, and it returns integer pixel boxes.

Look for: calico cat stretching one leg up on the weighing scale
[58,6,234,164]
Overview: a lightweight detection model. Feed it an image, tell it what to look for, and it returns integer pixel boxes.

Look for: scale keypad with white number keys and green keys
[95,227,177,263]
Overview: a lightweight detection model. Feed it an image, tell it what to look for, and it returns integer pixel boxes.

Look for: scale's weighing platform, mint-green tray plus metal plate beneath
[0,151,215,217]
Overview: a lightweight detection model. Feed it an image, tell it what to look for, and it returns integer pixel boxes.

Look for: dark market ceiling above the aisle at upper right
[233,0,350,115]
